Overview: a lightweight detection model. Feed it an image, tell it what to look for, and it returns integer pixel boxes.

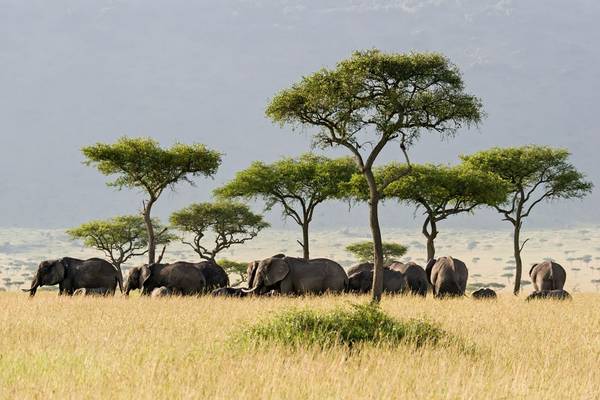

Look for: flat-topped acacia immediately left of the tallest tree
[215,153,356,260]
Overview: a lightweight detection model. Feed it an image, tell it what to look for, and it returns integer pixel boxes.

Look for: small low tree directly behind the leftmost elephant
[67,215,176,269]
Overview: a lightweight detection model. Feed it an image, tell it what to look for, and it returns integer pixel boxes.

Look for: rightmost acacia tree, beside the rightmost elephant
[462,146,593,295]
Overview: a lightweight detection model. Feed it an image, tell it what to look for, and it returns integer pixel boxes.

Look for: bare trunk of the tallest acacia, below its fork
[364,168,383,303]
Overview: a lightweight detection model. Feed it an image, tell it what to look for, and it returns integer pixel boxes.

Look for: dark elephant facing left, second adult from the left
[125,261,207,295]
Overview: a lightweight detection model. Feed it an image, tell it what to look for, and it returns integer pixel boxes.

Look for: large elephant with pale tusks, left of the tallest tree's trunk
[244,255,348,295]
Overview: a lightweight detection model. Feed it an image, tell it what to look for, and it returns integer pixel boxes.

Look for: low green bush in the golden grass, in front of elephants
[240,304,449,347]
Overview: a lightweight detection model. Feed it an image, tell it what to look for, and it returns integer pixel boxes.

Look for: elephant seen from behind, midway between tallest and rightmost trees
[425,257,469,298]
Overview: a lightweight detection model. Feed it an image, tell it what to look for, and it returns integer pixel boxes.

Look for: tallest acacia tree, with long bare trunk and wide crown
[266,50,482,302]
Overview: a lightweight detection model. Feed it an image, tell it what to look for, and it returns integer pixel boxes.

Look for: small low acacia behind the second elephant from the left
[170,201,269,260]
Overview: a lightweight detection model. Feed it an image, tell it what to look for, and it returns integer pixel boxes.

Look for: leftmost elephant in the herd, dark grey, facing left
[23,257,123,296]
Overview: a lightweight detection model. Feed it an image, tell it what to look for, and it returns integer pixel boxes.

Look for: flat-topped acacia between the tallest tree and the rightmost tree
[375,164,507,260]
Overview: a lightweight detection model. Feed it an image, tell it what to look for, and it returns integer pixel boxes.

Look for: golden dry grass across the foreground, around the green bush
[0,293,600,399]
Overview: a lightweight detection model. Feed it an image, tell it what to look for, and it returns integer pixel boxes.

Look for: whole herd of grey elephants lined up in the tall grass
[24,254,570,300]
